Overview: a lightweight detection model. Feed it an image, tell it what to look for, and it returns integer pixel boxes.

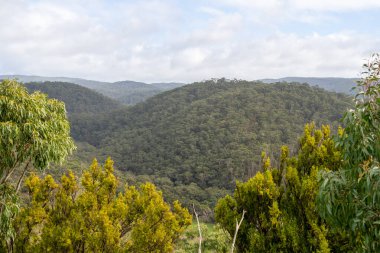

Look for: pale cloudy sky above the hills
[0,0,380,82]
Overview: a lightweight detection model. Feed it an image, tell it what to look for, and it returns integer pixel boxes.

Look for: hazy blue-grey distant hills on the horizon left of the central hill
[0,75,185,105]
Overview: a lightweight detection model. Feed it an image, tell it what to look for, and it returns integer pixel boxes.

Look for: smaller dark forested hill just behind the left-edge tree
[25,82,122,115]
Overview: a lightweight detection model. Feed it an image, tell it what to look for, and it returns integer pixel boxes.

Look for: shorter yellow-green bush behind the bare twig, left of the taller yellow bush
[215,170,280,252]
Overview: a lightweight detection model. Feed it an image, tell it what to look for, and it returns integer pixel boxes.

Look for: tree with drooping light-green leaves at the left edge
[0,80,75,249]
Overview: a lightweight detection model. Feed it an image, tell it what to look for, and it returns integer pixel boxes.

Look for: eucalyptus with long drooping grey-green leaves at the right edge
[318,55,380,252]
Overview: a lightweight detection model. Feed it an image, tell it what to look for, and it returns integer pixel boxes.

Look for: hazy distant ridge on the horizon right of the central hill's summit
[260,77,359,94]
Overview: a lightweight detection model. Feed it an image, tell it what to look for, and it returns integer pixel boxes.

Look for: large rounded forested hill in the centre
[77,79,350,211]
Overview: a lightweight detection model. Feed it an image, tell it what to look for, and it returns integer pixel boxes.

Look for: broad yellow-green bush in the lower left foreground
[15,159,191,252]
